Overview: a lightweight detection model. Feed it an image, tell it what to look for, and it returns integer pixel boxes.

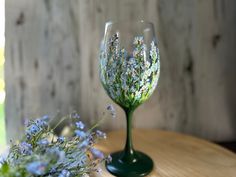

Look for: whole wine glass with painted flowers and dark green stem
[99,21,160,177]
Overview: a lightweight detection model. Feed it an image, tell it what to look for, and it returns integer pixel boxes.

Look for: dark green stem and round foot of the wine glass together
[106,109,153,177]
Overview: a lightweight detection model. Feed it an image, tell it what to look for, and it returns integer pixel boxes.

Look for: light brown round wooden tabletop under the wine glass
[97,130,236,177]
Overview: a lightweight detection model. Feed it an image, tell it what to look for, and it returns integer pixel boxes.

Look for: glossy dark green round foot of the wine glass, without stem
[106,151,153,177]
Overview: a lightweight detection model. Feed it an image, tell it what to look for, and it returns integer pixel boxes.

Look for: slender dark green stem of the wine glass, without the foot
[122,109,135,163]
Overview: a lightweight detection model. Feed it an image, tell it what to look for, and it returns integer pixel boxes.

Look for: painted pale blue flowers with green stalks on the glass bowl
[100,34,160,108]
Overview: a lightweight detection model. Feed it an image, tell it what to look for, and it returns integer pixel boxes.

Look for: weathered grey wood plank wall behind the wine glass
[5,0,236,141]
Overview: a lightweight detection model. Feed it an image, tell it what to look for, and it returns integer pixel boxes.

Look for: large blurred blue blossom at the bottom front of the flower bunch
[26,161,48,175]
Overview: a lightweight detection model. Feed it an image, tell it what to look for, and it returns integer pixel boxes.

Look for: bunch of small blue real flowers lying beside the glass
[0,106,115,177]
